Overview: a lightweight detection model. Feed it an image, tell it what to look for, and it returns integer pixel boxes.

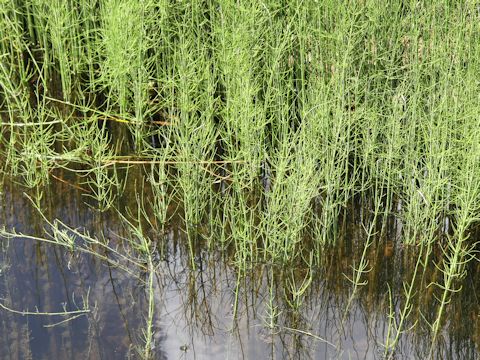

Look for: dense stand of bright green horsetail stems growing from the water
[0,0,480,358]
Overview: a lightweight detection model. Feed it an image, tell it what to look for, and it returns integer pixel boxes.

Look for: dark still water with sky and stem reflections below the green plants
[0,179,480,359]
